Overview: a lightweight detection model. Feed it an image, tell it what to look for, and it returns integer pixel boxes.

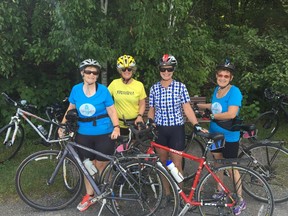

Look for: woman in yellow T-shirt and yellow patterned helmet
[108,55,147,135]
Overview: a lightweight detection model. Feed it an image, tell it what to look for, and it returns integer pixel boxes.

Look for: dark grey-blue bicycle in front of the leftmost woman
[15,132,179,216]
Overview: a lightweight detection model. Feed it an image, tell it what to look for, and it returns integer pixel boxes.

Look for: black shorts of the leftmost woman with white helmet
[75,134,115,161]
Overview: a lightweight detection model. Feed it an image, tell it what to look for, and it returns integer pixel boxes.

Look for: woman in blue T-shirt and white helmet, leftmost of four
[58,59,120,212]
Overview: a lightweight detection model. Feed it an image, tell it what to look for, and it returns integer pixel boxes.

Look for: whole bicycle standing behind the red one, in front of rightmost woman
[183,120,288,203]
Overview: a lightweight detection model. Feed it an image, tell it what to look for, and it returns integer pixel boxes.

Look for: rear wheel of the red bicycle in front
[196,165,274,216]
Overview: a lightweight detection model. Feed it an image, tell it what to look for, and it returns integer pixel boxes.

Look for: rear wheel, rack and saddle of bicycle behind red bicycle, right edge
[238,124,288,203]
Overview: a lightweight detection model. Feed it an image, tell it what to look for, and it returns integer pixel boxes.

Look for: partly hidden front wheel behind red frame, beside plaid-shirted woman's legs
[182,136,204,181]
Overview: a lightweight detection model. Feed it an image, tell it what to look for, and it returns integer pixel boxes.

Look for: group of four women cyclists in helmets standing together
[58,54,246,215]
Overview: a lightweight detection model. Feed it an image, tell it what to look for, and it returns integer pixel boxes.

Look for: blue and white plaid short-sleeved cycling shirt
[149,80,190,126]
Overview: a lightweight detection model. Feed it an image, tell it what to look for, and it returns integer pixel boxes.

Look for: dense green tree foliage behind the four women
[0,0,288,123]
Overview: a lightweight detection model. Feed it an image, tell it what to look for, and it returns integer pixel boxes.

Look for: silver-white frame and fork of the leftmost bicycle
[4,108,69,145]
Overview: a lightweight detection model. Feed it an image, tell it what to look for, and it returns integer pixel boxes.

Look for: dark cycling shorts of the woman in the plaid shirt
[156,125,185,151]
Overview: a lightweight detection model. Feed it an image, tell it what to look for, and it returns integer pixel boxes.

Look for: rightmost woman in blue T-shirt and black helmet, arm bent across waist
[198,60,246,215]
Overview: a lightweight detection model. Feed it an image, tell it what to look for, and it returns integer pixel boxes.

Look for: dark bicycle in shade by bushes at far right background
[255,88,288,140]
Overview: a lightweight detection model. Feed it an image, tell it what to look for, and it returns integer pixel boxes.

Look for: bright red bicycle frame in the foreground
[150,141,236,215]
